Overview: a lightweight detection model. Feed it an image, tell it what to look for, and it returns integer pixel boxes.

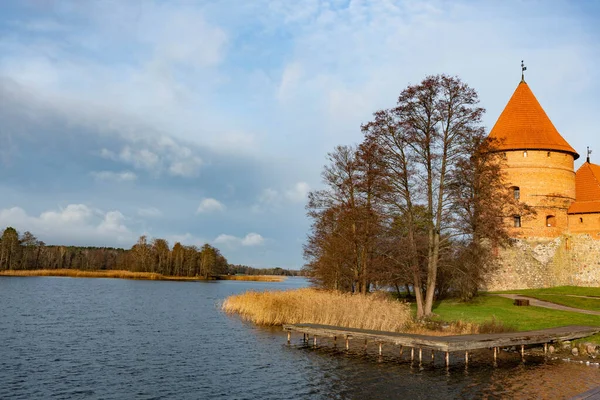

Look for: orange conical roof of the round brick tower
[490,81,579,159]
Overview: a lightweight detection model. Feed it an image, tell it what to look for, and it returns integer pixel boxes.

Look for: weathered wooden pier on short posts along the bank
[283,324,600,366]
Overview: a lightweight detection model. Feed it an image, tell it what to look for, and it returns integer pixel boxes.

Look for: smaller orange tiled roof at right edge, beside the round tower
[568,162,600,214]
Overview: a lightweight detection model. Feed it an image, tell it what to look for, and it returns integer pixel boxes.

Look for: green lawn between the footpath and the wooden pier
[433,296,600,331]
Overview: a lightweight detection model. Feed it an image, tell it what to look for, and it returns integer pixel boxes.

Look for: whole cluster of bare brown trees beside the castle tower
[304,75,532,317]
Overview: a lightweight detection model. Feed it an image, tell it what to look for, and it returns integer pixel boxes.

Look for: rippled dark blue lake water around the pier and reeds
[0,277,600,399]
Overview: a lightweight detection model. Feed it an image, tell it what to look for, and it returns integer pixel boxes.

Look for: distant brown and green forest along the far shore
[0,227,301,278]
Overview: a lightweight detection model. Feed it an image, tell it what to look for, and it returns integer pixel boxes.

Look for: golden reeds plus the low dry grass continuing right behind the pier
[222,288,515,336]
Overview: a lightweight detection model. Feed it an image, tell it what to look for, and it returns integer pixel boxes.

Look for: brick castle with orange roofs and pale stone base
[486,75,600,290]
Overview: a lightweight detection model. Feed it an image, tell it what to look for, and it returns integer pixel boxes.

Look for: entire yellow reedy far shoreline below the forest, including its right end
[0,268,286,282]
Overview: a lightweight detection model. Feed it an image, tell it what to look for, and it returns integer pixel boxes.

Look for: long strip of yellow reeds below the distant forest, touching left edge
[0,269,199,281]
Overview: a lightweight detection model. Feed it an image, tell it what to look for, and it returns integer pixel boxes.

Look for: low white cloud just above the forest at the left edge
[0,204,135,246]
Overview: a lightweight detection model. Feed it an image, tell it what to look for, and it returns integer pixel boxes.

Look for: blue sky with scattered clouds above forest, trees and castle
[0,0,600,269]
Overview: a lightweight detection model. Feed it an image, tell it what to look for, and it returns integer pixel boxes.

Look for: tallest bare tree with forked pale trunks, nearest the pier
[363,75,484,317]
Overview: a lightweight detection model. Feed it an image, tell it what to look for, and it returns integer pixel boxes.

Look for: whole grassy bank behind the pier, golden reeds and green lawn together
[223,288,600,341]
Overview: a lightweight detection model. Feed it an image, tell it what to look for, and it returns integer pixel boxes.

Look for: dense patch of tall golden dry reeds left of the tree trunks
[222,288,412,332]
